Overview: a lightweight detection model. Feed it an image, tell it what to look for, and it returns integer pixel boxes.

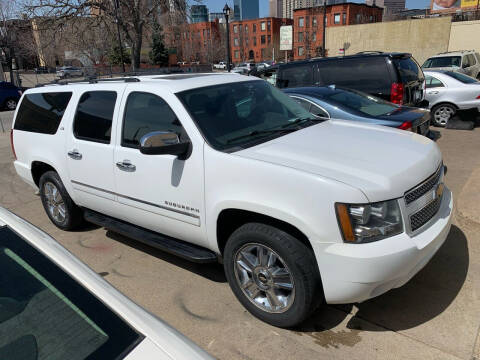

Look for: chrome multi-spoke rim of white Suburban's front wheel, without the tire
[234,243,295,313]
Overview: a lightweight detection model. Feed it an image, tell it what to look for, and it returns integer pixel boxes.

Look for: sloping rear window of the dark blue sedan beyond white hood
[321,87,399,116]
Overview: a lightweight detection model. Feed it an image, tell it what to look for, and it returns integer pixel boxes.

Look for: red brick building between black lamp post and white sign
[230,17,293,63]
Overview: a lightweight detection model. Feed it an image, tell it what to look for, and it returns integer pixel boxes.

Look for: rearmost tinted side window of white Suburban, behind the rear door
[14,92,72,135]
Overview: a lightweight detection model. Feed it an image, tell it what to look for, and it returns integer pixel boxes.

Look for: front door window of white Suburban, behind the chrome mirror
[122,92,188,148]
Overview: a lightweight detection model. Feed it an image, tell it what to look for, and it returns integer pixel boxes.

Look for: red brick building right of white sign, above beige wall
[293,3,383,60]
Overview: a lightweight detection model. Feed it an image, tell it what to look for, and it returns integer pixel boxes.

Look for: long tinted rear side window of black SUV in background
[318,57,392,95]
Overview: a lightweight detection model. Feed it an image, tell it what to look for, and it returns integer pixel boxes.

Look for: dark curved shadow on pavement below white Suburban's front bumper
[296,225,469,332]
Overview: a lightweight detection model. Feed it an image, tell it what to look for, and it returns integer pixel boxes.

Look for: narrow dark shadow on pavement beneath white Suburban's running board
[106,230,227,283]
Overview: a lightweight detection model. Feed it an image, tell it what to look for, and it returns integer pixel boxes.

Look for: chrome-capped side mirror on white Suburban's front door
[140,131,191,160]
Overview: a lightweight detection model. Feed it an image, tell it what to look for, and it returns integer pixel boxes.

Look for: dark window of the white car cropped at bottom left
[0,226,142,360]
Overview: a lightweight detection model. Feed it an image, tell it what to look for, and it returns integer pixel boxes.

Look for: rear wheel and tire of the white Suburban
[39,171,83,230]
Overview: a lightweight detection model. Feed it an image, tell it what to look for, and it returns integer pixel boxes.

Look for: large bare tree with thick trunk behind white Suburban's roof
[23,0,186,69]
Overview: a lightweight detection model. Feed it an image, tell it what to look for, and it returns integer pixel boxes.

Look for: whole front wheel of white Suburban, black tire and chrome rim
[224,223,323,328]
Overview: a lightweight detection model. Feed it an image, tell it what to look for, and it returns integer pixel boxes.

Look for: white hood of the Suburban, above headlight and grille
[235,120,442,202]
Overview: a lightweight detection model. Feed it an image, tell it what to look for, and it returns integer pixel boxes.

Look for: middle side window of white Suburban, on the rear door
[73,91,117,144]
